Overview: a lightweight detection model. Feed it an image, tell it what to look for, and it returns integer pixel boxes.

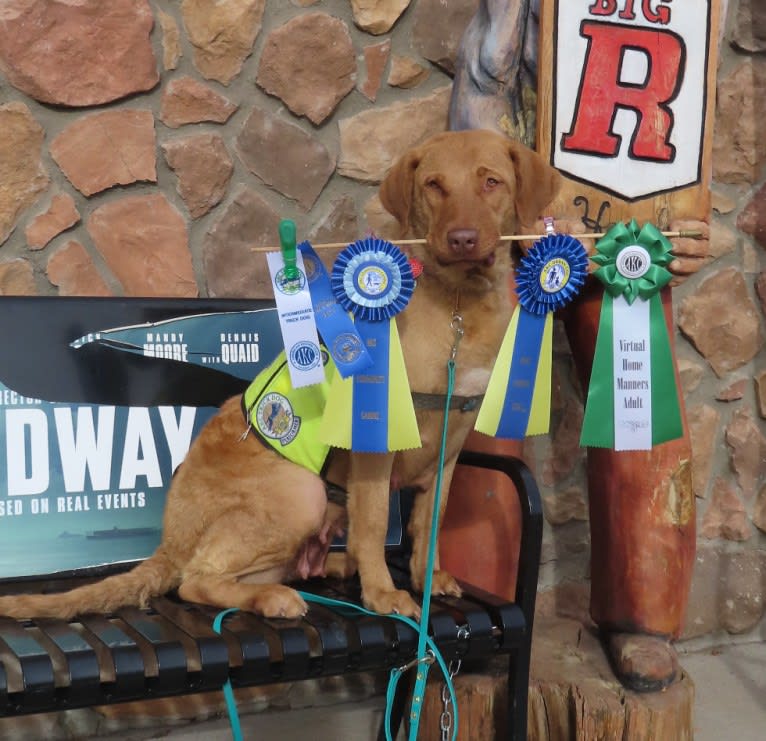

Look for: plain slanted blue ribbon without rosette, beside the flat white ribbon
[298,242,372,378]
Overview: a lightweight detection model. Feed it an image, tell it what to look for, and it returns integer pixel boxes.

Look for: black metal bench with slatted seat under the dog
[0,297,542,741]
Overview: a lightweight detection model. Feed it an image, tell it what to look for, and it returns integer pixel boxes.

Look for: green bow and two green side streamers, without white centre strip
[580,219,683,448]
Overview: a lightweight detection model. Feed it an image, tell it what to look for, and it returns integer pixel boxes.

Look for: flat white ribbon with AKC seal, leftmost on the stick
[266,250,325,389]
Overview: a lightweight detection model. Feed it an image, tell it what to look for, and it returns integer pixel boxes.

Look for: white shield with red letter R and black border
[552,0,711,201]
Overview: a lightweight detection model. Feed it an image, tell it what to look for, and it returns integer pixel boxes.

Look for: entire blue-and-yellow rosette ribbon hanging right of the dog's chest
[475,234,588,440]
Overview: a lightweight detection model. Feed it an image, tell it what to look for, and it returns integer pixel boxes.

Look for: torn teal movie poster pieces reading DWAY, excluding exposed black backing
[0,309,281,579]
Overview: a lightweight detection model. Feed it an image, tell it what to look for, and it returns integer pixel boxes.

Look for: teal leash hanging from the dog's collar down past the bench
[213,310,463,741]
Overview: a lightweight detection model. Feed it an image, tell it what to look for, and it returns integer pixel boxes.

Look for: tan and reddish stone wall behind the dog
[0,0,766,637]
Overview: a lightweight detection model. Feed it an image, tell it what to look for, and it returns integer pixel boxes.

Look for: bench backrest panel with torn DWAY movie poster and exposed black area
[0,298,281,579]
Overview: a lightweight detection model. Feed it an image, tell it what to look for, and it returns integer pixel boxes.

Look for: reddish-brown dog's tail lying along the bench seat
[0,548,181,620]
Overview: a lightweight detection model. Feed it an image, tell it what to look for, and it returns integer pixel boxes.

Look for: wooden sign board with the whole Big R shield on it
[538,0,718,225]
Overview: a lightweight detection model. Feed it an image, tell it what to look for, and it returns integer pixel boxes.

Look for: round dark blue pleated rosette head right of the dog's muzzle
[516,234,588,316]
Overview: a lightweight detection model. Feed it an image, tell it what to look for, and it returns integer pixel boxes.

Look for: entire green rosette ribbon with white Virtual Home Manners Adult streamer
[580,219,683,450]
